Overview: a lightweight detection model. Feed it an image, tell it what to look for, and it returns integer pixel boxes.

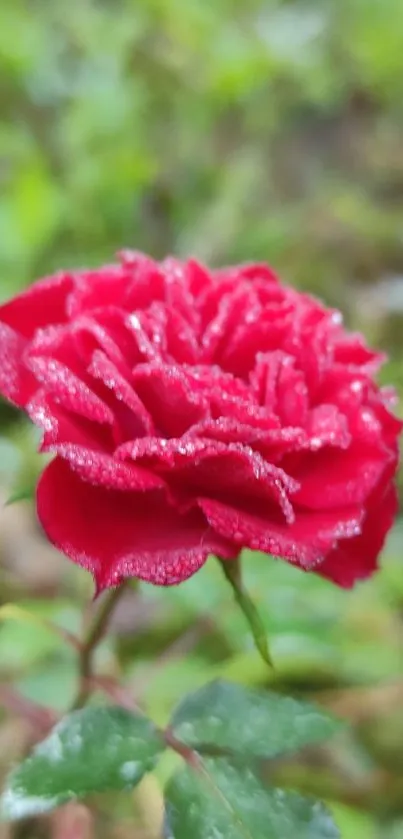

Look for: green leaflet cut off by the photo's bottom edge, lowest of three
[165,759,339,839]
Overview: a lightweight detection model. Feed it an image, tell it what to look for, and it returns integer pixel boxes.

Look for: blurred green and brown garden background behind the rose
[0,0,403,839]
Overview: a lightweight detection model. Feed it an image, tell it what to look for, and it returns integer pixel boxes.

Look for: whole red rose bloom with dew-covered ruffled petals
[0,253,401,591]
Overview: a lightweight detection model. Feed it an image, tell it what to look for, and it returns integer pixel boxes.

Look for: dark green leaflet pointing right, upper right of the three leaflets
[171,681,341,758]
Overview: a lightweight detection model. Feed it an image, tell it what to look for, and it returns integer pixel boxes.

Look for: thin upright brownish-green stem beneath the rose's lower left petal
[71,584,125,711]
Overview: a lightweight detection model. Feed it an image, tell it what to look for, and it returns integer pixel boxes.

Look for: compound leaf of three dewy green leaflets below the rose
[0,683,338,839]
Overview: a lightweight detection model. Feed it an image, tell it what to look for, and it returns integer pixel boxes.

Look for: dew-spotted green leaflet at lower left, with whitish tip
[0,707,164,821]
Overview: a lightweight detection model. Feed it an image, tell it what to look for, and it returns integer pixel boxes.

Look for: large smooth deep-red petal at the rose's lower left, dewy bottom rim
[37,458,237,593]
